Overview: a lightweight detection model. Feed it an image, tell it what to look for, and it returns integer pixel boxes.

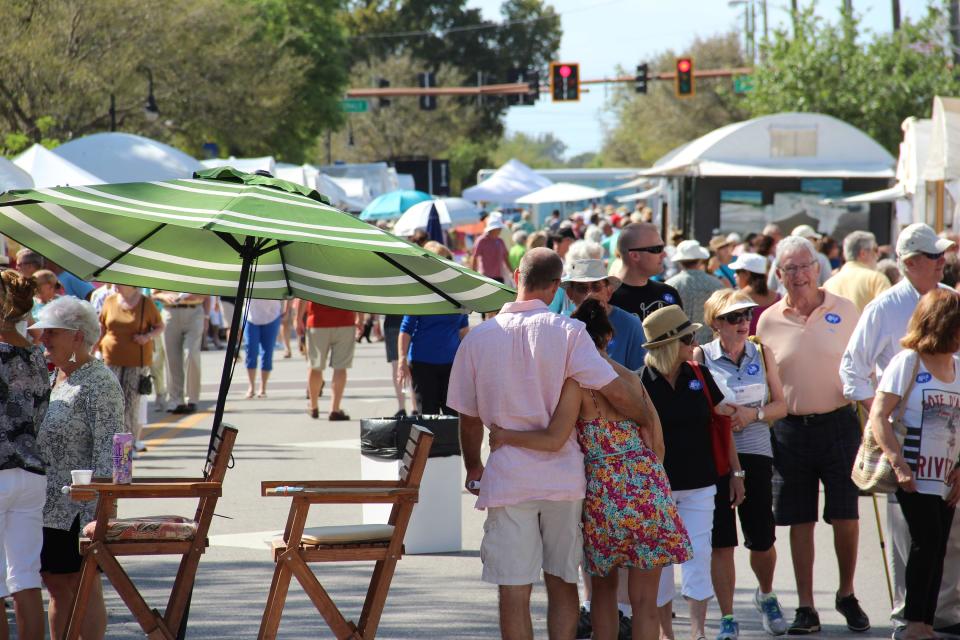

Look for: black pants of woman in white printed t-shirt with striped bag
[897,489,954,625]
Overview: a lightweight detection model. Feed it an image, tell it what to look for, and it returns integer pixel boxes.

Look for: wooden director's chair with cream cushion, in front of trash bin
[257,425,433,640]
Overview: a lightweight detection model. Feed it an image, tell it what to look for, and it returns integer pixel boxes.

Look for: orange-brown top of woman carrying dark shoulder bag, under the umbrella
[100,293,163,367]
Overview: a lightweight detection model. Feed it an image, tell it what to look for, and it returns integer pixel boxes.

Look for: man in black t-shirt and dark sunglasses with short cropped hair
[610,222,683,321]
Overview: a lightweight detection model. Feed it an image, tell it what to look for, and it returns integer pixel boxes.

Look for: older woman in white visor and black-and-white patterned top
[34,296,123,640]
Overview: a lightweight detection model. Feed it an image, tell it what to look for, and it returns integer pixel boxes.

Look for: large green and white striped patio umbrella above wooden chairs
[0,167,514,315]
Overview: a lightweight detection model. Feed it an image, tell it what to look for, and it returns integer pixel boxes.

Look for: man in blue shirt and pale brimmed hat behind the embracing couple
[560,260,646,370]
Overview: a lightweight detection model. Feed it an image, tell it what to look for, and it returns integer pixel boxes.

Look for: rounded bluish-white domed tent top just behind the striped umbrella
[53,132,203,183]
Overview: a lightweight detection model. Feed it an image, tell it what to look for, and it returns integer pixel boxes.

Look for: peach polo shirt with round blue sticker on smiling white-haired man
[757,289,860,415]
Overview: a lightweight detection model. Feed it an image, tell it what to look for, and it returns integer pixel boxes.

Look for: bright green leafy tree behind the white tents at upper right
[745,4,960,155]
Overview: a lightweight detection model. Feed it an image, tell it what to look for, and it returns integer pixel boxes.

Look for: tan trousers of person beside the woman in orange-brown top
[163,304,203,408]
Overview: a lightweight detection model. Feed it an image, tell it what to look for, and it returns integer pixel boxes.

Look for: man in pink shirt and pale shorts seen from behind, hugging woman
[447,248,643,640]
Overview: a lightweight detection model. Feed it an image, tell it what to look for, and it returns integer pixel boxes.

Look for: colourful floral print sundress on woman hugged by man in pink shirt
[577,391,693,576]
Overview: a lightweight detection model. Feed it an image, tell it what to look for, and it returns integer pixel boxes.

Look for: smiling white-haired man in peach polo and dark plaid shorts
[757,236,870,635]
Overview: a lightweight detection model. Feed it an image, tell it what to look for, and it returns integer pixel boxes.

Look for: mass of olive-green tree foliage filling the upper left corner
[0,0,345,160]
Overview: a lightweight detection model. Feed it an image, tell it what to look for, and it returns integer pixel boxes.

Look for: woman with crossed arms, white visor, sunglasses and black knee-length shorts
[694,289,787,640]
